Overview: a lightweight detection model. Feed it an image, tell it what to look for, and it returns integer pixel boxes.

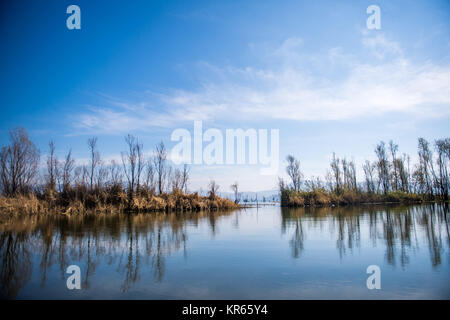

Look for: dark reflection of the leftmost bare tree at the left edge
[0,232,31,298]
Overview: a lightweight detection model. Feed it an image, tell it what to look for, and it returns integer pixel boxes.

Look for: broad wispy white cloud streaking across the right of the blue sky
[72,34,450,132]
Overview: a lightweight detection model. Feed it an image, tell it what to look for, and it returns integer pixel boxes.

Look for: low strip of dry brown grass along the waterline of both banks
[0,193,449,215]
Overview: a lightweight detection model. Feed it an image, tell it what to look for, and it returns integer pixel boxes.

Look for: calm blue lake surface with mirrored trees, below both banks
[0,205,450,299]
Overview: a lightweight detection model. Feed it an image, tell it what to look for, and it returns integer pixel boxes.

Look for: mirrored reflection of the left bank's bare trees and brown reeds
[0,211,231,298]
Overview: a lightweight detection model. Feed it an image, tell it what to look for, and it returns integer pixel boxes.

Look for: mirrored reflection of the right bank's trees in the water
[281,204,450,267]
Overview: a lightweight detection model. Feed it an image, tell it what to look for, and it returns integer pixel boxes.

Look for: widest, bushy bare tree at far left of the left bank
[0,128,39,196]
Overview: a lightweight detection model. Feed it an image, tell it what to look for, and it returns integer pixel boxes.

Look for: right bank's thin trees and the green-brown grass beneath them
[279,138,450,207]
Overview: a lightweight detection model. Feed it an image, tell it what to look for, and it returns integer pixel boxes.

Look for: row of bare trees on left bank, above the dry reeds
[0,128,189,197]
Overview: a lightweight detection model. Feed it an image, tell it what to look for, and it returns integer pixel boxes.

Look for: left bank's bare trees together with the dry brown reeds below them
[0,128,237,212]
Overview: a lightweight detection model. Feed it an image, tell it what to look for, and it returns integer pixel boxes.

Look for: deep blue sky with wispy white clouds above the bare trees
[0,1,450,191]
